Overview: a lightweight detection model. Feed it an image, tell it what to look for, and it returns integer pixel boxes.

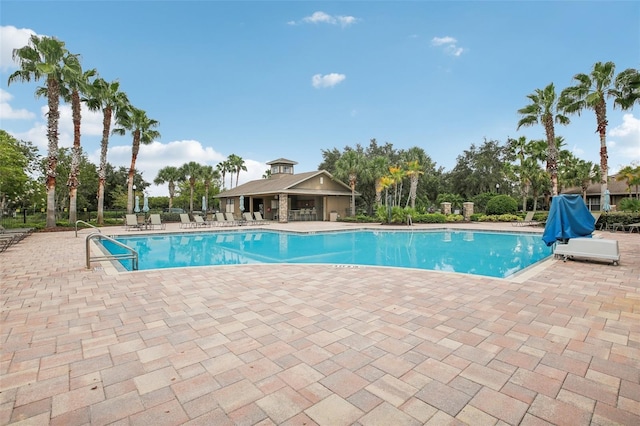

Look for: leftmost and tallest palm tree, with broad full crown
[7,35,68,228]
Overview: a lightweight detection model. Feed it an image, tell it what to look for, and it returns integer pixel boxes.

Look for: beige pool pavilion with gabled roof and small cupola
[214,158,360,223]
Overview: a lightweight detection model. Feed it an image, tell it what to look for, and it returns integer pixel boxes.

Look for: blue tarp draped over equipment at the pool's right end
[542,194,596,246]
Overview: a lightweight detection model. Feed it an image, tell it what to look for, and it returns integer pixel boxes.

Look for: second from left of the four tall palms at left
[60,54,97,224]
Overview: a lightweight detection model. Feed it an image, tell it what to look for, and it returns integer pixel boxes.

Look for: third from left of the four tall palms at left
[84,78,129,225]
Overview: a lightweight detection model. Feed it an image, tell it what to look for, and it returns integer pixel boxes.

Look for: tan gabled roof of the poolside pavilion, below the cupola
[213,170,360,198]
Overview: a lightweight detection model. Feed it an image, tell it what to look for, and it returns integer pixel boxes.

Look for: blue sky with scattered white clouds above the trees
[0,0,640,195]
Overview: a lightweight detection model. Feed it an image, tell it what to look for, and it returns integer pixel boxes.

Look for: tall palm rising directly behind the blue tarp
[518,83,569,197]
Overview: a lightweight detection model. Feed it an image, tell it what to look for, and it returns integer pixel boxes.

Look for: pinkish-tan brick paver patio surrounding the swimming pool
[0,222,640,426]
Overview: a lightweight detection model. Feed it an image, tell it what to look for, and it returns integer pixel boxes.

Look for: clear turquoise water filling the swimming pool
[103,230,552,278]
